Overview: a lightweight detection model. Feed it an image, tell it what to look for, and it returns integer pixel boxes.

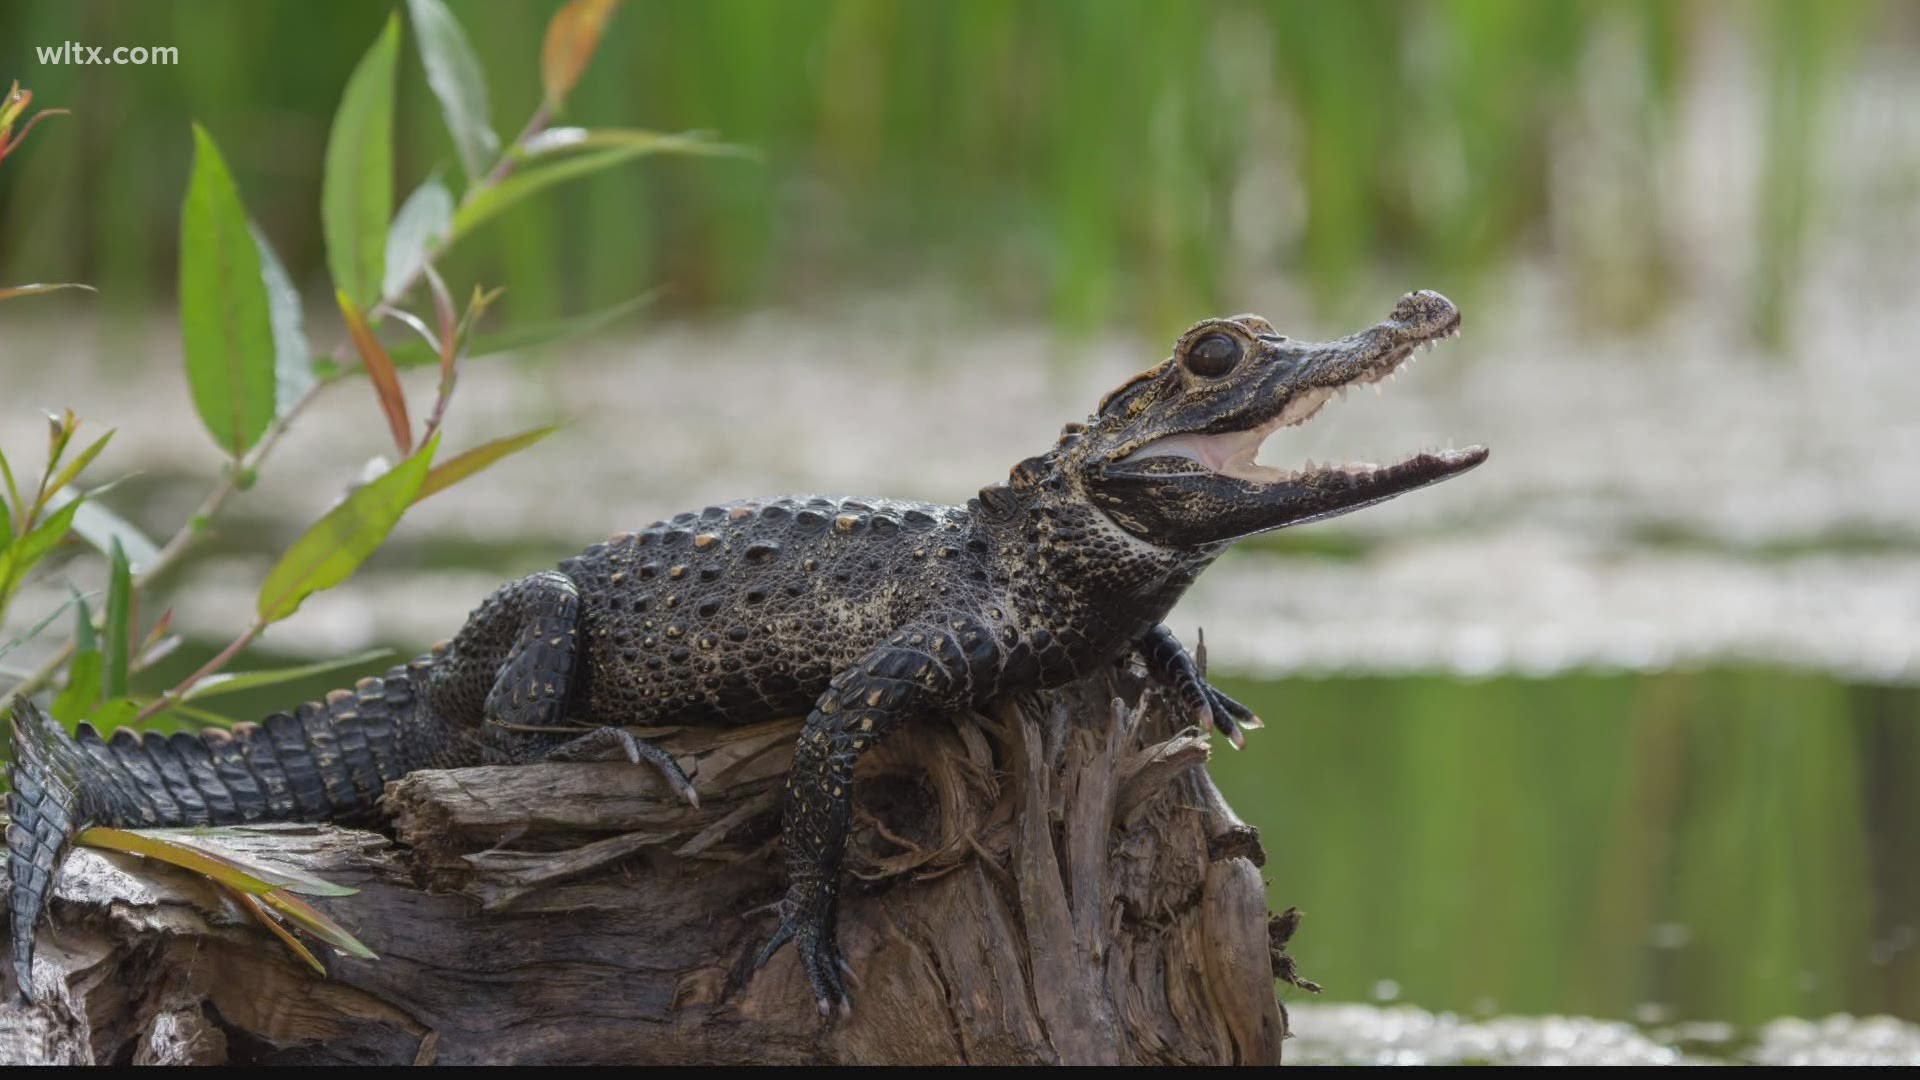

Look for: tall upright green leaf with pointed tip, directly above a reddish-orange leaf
[321,13,399,309]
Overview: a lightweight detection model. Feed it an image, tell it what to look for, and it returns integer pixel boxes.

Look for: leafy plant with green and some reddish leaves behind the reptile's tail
[0,0,714,749]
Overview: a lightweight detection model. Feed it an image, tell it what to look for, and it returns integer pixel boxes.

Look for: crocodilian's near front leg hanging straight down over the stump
[755,617,1000,1015]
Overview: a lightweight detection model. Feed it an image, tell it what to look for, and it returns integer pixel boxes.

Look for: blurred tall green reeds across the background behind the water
[0,0,1889,340]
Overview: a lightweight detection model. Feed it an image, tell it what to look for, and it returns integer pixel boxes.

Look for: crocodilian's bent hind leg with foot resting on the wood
[432,571,699,805]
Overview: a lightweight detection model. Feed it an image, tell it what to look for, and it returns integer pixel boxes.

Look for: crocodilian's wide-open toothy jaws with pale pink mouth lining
[1121,292,1486,505]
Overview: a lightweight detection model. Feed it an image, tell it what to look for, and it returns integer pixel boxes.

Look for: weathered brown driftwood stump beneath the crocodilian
[0,671,1286,1065]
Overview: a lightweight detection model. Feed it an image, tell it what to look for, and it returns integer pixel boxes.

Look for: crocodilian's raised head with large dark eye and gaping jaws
[1052,292,1486,548]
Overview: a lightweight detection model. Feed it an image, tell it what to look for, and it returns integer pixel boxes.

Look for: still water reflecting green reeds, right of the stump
[1213,669,1920,1026]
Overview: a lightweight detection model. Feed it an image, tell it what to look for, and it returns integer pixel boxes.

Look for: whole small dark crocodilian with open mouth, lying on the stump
[8,292,1486,1015]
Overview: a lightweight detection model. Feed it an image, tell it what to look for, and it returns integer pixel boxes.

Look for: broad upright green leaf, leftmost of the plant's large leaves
[180,125,275,459]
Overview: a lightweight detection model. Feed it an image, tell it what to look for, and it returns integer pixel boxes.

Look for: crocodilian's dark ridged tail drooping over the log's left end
[6,657,441,997]
